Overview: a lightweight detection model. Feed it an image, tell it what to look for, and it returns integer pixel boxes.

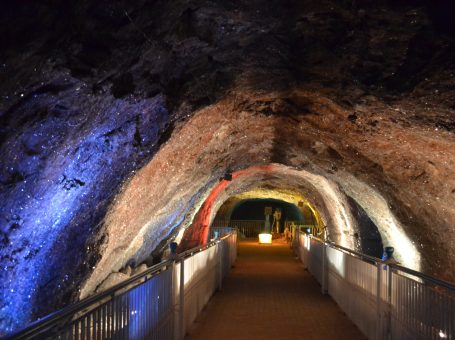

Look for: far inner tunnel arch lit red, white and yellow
[178,164,396,262]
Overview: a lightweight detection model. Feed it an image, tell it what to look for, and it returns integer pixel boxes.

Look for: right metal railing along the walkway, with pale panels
[294,233,455,339]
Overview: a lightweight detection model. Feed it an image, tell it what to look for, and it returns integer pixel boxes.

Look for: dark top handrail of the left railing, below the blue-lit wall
[6,231,235,340]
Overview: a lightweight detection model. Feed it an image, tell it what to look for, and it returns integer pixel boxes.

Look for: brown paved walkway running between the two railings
[186,241,365,340]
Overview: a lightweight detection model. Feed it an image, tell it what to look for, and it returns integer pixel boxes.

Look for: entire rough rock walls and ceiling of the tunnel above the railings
[0,0,455,334]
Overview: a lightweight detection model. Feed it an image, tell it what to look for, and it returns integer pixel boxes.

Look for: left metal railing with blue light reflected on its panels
[6,230,237,340]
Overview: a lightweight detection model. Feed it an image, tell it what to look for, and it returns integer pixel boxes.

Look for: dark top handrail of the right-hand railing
[302,235,455,292]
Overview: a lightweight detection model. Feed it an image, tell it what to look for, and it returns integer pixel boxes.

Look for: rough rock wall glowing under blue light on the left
[0,77,168,334]
